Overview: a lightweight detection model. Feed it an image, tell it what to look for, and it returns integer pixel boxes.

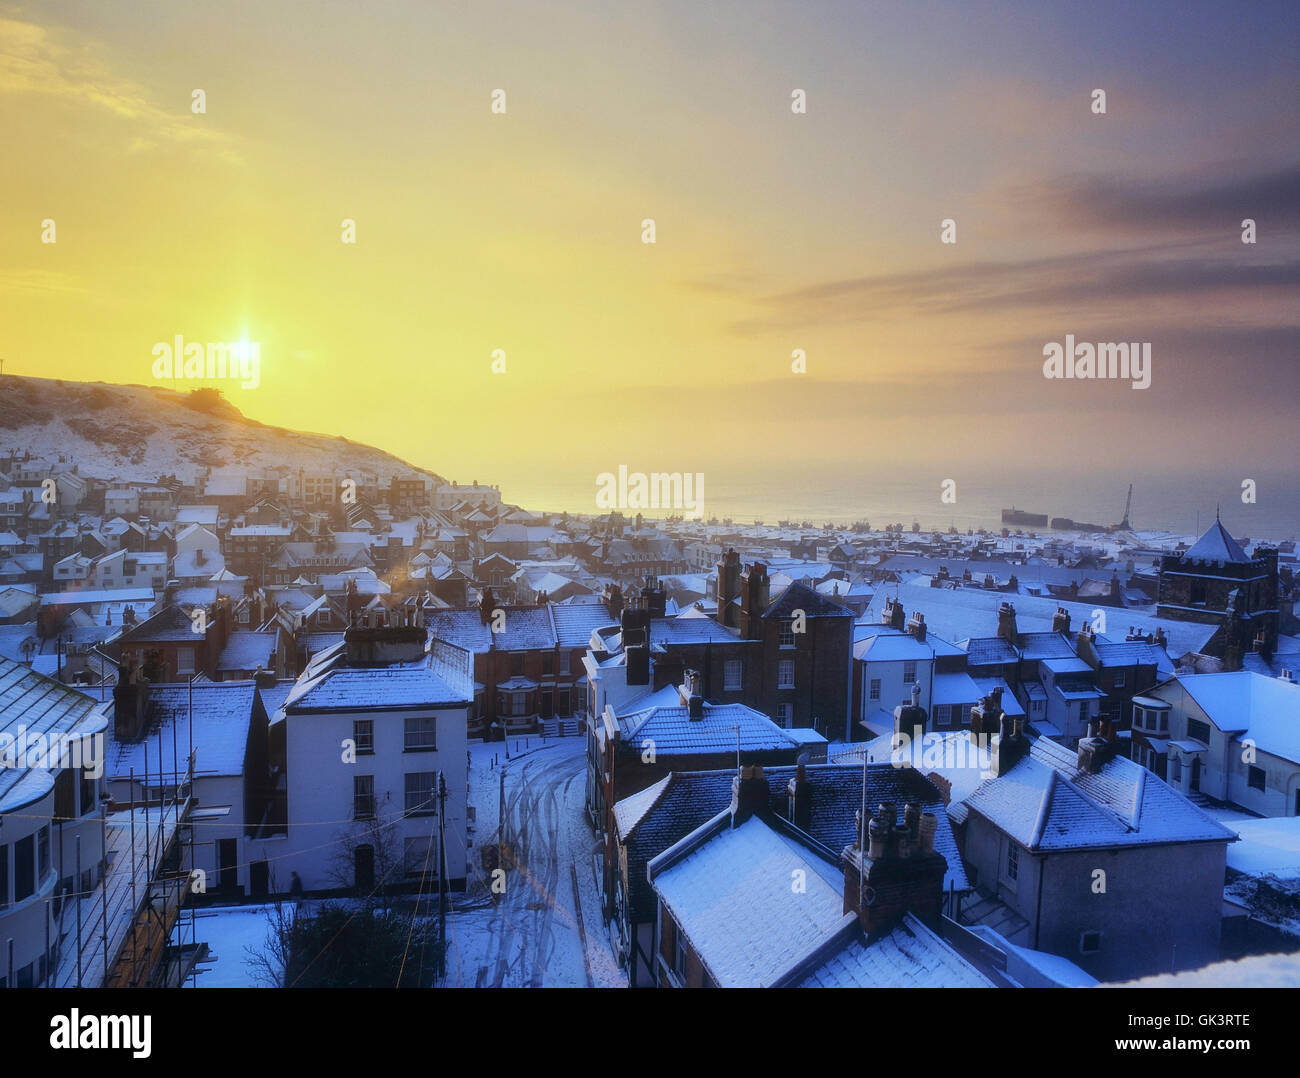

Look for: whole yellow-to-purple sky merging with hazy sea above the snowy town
[0,0,1300,522]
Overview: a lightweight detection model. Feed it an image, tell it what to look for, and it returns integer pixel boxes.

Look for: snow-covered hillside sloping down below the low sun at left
[0,375,442,482]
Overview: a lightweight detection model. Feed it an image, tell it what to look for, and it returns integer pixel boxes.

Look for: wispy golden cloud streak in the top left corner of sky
[0,18,241,164]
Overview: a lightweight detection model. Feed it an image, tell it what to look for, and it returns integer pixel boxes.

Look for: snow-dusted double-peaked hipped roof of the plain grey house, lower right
[965,737,1235,850]
